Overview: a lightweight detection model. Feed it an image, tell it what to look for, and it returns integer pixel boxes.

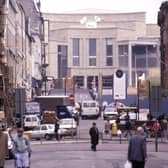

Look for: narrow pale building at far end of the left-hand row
[17,0,44,95]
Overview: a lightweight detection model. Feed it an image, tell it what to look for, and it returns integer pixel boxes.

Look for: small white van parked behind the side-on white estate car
[24,115,40,129]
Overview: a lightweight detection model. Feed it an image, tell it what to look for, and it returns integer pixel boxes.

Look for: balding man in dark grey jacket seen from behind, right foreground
[128,127,147,168]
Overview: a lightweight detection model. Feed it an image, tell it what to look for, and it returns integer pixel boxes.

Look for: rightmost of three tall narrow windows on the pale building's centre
[106,39,113,66]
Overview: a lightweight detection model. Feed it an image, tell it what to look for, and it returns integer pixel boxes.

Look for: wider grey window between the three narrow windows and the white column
[118,45,128,68]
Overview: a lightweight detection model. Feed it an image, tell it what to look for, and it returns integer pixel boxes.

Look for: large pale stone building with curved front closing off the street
[43,9,160,91]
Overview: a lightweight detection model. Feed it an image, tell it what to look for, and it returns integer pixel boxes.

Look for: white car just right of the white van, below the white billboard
[103,106,118,120]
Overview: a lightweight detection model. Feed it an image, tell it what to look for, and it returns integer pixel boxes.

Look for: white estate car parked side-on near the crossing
[25,124,55,140]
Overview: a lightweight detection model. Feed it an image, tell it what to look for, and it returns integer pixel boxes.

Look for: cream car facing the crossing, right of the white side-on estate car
[58,118,77,138]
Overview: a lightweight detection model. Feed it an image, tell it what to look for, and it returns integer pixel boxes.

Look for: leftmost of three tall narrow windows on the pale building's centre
[72,38,80,66]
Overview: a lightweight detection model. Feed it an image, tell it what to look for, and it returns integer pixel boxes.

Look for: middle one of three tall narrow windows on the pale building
[89,39,96,66]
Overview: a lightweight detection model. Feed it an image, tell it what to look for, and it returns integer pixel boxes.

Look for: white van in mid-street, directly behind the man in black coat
[81,100,100,119]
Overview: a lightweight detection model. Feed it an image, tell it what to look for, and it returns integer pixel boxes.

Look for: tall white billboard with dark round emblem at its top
[113,70,126,100]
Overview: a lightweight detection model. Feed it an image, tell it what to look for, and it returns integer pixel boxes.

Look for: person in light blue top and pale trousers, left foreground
[13,128,31,168]
